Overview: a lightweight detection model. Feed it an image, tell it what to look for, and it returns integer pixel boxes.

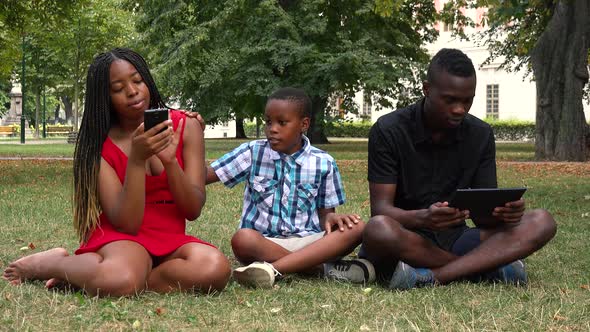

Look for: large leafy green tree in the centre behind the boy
[134,0,436,143]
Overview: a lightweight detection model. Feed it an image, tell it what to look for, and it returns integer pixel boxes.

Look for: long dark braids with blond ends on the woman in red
[73,48,166,242]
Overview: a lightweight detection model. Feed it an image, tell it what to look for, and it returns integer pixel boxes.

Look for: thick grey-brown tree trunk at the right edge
[531,0,590,161]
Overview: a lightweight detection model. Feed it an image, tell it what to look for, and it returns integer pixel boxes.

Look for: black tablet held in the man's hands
[449,187,526,227]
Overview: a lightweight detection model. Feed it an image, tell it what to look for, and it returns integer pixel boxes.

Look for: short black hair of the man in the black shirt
[426,48,475,83]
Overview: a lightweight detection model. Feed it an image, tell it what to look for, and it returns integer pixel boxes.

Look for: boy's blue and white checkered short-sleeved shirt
[211,136,346,237]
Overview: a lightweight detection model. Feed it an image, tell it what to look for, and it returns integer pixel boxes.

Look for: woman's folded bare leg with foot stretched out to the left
[4,241,152,296]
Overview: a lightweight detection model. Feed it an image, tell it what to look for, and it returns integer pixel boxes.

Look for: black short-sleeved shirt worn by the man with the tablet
[368,99,497,210]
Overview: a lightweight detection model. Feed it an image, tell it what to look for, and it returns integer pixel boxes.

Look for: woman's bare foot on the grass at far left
[3,248,68,285]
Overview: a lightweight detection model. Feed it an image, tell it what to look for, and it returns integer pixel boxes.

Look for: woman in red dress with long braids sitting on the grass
[4,49,231,296]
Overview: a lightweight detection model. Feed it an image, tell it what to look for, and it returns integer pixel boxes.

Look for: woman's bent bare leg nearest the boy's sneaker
[148,243,231,293]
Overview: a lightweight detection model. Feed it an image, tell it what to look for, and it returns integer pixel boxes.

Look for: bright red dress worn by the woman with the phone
[76,111,214,256]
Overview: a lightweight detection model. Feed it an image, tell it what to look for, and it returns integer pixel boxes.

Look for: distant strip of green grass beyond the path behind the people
[0,139,535,161]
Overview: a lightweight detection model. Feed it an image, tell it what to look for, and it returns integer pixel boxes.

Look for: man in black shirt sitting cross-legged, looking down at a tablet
[361,49,556,289]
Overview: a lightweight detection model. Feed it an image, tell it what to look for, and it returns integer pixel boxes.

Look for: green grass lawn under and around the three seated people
[0,140,590,331]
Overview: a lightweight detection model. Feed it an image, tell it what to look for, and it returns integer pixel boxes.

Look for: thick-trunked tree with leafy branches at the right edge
[447,0,590,161]
